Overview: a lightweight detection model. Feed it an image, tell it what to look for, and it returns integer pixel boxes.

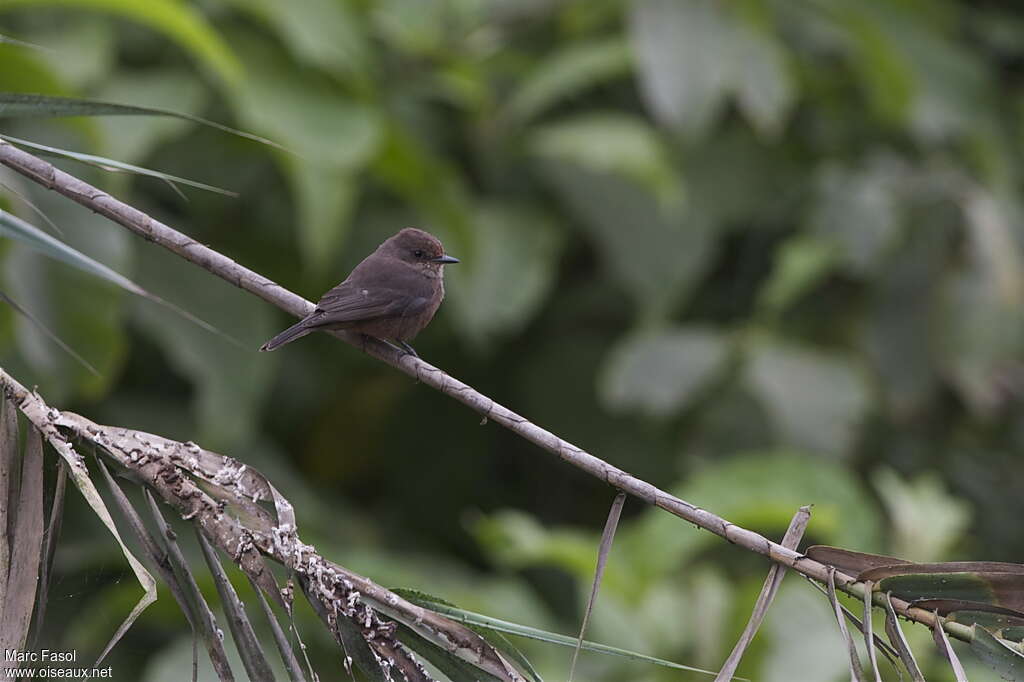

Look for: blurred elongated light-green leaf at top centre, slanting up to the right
[506,38,633,124]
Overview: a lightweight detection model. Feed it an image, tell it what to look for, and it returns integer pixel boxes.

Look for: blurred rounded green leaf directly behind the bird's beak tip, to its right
[444,199,562,345]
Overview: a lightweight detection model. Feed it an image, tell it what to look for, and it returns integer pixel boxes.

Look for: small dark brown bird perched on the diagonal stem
[260,227,459,355]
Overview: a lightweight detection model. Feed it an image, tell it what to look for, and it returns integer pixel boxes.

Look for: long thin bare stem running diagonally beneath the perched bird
[0,140,973,642]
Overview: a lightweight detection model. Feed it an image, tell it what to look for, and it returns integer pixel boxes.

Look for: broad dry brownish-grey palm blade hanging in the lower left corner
[0,428,43,668]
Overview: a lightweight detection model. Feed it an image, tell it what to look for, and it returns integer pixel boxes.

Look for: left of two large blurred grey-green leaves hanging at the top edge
[630,0,734,135]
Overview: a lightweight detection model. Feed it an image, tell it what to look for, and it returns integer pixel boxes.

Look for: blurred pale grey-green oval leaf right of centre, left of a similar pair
[600,327,728,417]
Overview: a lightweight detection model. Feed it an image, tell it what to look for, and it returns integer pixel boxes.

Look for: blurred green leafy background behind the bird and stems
[0,0,1024,681]
